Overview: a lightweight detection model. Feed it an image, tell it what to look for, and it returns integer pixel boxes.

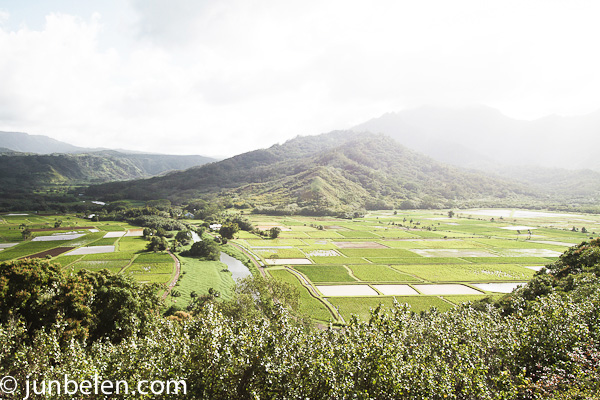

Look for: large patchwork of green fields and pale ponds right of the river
[235,209,600,323]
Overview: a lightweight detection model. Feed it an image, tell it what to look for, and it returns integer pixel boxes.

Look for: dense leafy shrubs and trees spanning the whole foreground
[0,240,600,399]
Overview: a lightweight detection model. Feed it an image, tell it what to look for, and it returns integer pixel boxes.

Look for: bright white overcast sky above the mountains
[0,0,600,156]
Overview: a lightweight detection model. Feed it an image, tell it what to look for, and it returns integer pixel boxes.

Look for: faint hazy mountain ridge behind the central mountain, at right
[351,106,600,171]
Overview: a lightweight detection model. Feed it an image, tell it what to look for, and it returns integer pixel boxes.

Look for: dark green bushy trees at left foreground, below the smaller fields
[0,259,159,342]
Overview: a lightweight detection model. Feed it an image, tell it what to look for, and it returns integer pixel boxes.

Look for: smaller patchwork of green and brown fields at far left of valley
[0,213,175,290]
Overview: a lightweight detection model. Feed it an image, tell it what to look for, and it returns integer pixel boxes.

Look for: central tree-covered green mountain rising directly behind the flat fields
[87,131,533,210]
